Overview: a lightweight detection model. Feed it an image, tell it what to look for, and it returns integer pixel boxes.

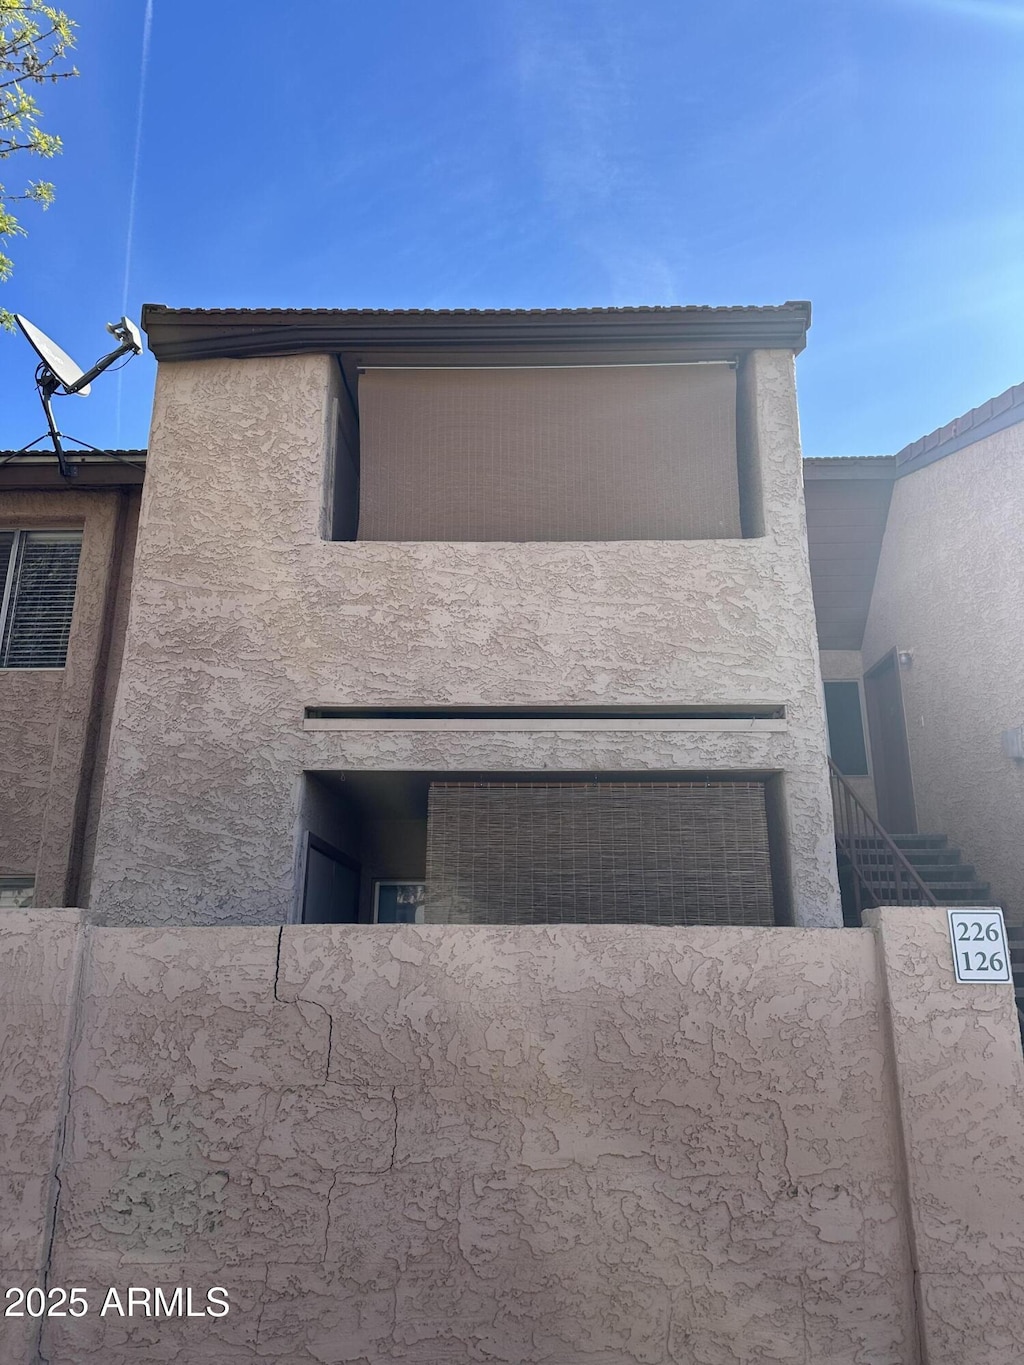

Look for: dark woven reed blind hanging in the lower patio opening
[425,781,774,925]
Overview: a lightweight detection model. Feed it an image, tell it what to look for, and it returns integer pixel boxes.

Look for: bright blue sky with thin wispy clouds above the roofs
[0,0,1024,455]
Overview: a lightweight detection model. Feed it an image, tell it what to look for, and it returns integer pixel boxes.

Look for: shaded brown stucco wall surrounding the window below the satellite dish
[0,490,132,905]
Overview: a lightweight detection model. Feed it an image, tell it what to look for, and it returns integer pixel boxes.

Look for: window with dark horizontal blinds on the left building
[0,531,82,669]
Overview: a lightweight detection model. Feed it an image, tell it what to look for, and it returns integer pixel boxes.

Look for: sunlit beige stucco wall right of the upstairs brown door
[863,425,1024,923]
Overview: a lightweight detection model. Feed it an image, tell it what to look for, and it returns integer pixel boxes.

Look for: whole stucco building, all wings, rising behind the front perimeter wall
[0,304,1024,924]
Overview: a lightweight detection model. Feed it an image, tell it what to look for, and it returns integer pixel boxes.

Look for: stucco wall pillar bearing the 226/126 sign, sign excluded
[866,909,1024,1365]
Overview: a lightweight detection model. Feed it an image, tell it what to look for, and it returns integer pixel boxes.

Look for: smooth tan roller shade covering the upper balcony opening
[358,364,741,542]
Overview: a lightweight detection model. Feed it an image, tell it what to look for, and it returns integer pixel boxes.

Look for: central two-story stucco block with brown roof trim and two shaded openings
[91,304,840,924]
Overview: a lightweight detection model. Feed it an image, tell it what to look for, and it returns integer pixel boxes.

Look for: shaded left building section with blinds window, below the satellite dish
[0,450,146,906]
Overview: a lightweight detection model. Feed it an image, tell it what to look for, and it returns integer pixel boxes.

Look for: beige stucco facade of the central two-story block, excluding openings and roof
[90,352,840,924]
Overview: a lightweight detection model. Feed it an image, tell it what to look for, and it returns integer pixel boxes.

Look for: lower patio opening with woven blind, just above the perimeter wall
[298,771,789,925]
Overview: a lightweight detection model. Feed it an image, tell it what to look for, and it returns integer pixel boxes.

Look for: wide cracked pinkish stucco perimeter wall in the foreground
[0,915,928,1365]
